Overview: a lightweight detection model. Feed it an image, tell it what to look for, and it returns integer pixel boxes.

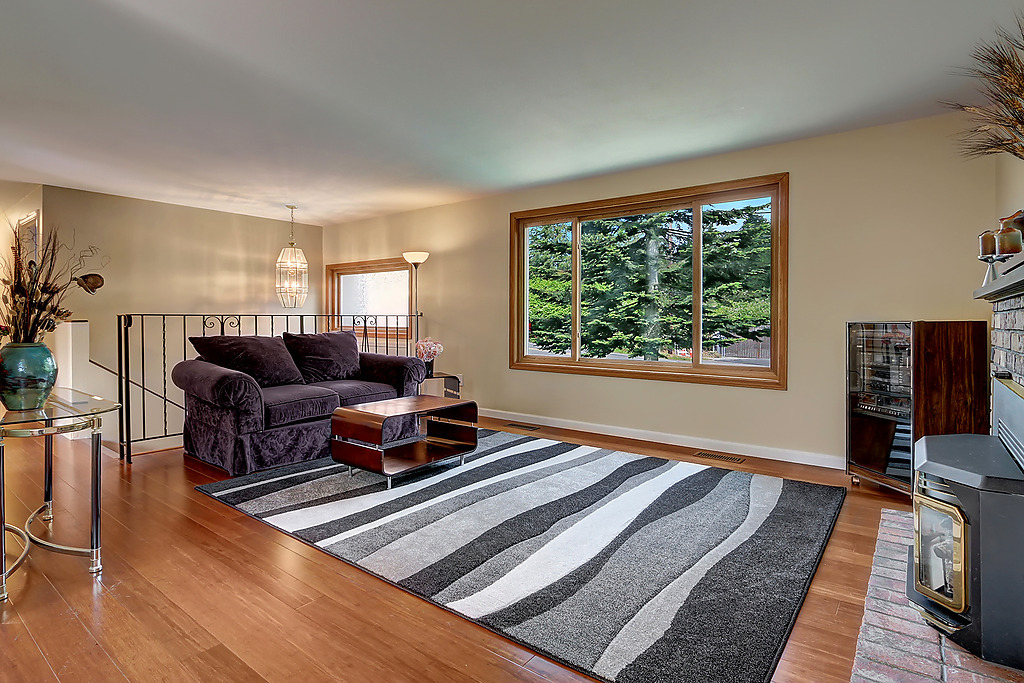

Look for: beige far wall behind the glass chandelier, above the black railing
[43,185,324,368]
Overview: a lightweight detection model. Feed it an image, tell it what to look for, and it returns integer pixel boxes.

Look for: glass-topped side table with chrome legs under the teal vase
[0,387,120,602]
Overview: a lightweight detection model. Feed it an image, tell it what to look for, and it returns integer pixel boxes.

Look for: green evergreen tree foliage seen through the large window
[528,204,771,360]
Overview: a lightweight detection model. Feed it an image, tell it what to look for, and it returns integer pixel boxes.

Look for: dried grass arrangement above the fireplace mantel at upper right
[944,16,1024,159]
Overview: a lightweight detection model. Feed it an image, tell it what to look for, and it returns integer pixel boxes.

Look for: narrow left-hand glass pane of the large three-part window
[526,223,572,355]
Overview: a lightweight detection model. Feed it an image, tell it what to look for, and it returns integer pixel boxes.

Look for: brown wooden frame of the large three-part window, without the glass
[509,173,790,390]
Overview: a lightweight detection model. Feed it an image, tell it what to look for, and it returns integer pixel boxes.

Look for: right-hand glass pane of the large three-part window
[700,197,772,368]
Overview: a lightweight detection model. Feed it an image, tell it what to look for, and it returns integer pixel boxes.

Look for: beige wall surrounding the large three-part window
[324,115,995,466]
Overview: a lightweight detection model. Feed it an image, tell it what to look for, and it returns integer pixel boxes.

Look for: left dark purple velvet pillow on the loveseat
[188,335,304,387]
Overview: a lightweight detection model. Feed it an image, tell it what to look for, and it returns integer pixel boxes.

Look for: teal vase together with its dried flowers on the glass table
[0,228,103,411]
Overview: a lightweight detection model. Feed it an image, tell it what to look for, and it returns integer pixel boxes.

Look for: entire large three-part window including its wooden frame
[510,173,788,389]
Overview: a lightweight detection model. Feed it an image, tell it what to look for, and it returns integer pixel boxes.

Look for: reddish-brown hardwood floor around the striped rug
[0,419,909,683]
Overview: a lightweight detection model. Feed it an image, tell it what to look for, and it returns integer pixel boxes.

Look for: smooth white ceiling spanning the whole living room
[0,0,1024,223]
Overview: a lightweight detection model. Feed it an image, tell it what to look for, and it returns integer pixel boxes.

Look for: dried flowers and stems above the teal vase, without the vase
[0,228,103,344]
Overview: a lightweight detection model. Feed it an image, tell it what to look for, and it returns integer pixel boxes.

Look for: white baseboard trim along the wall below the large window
[480,408,846,470]
